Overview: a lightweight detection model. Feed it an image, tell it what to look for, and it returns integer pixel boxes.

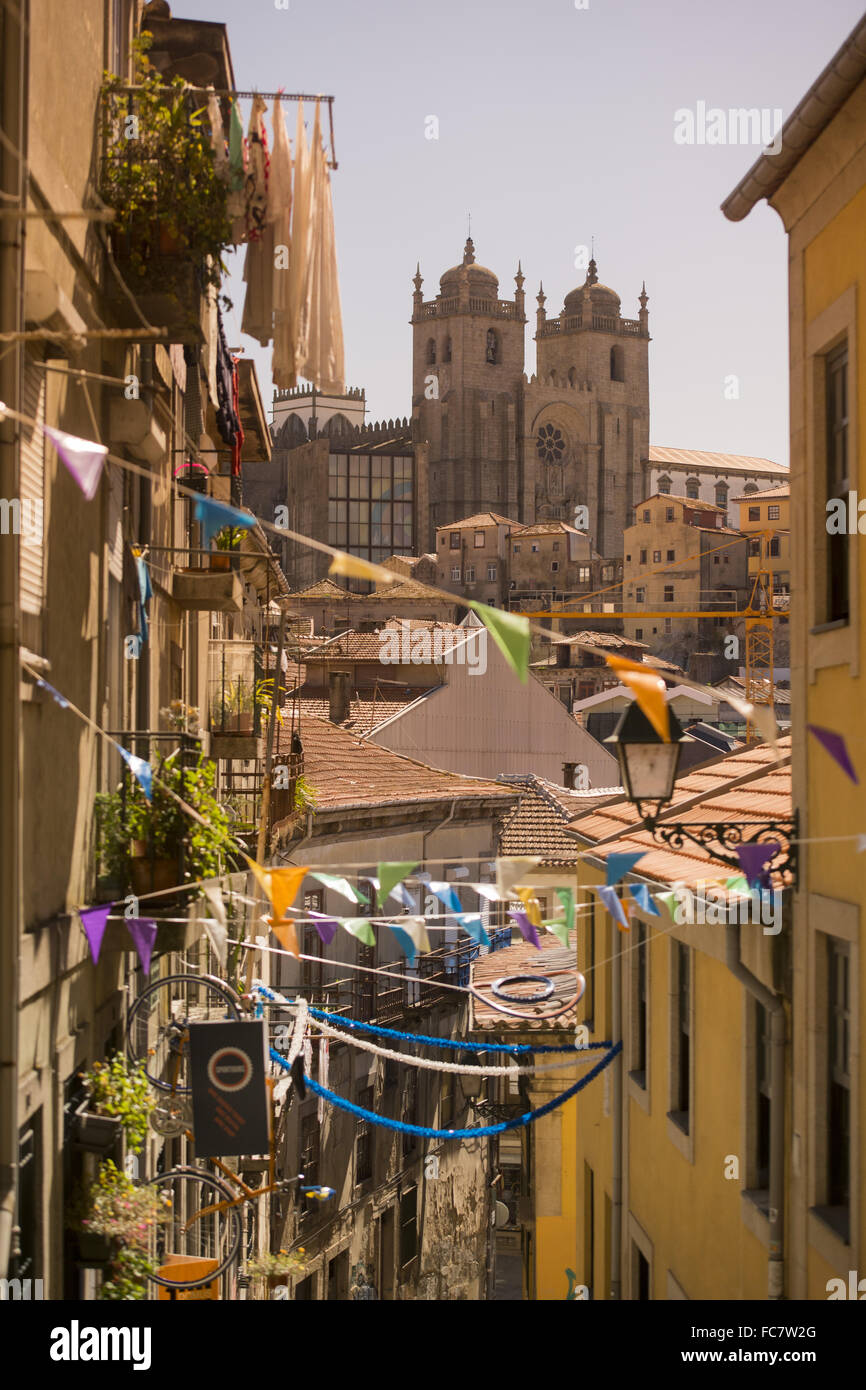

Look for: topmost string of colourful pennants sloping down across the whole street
[6,402,859,785]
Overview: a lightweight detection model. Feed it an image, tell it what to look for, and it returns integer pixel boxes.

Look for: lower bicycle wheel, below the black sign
[147,1168,240,1289]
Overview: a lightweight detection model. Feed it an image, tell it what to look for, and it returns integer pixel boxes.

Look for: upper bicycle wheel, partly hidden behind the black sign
[126,974,240,1095]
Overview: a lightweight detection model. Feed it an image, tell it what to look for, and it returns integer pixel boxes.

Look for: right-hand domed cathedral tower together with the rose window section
[520,260,649,560]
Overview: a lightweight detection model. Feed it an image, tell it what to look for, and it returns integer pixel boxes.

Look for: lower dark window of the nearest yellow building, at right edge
[827,937,851,1238]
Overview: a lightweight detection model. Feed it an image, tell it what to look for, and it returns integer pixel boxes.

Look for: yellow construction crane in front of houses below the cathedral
[532,531,788,744]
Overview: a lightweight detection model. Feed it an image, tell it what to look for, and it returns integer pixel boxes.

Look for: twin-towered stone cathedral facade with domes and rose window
[411,238,649,559]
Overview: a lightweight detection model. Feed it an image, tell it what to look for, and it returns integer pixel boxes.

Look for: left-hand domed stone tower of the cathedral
[411,238,525,549]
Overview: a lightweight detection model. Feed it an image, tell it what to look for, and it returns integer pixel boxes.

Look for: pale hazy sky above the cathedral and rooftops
[172,0,862,461]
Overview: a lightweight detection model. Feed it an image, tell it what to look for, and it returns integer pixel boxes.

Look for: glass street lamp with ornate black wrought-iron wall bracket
[605,701,798,887]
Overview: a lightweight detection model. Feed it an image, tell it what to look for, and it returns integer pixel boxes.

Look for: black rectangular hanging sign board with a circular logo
[189,1019,270,1158]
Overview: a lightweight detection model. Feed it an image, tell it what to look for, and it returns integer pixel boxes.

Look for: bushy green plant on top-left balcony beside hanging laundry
[100,35,232,291]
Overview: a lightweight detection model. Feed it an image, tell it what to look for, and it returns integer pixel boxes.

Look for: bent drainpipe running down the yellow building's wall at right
[724,922,785,1300]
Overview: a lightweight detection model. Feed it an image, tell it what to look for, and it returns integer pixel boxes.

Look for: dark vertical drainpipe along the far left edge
[0,0,29,1277]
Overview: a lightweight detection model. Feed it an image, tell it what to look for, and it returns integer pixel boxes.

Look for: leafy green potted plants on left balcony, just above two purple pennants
[96,753,238,884]
